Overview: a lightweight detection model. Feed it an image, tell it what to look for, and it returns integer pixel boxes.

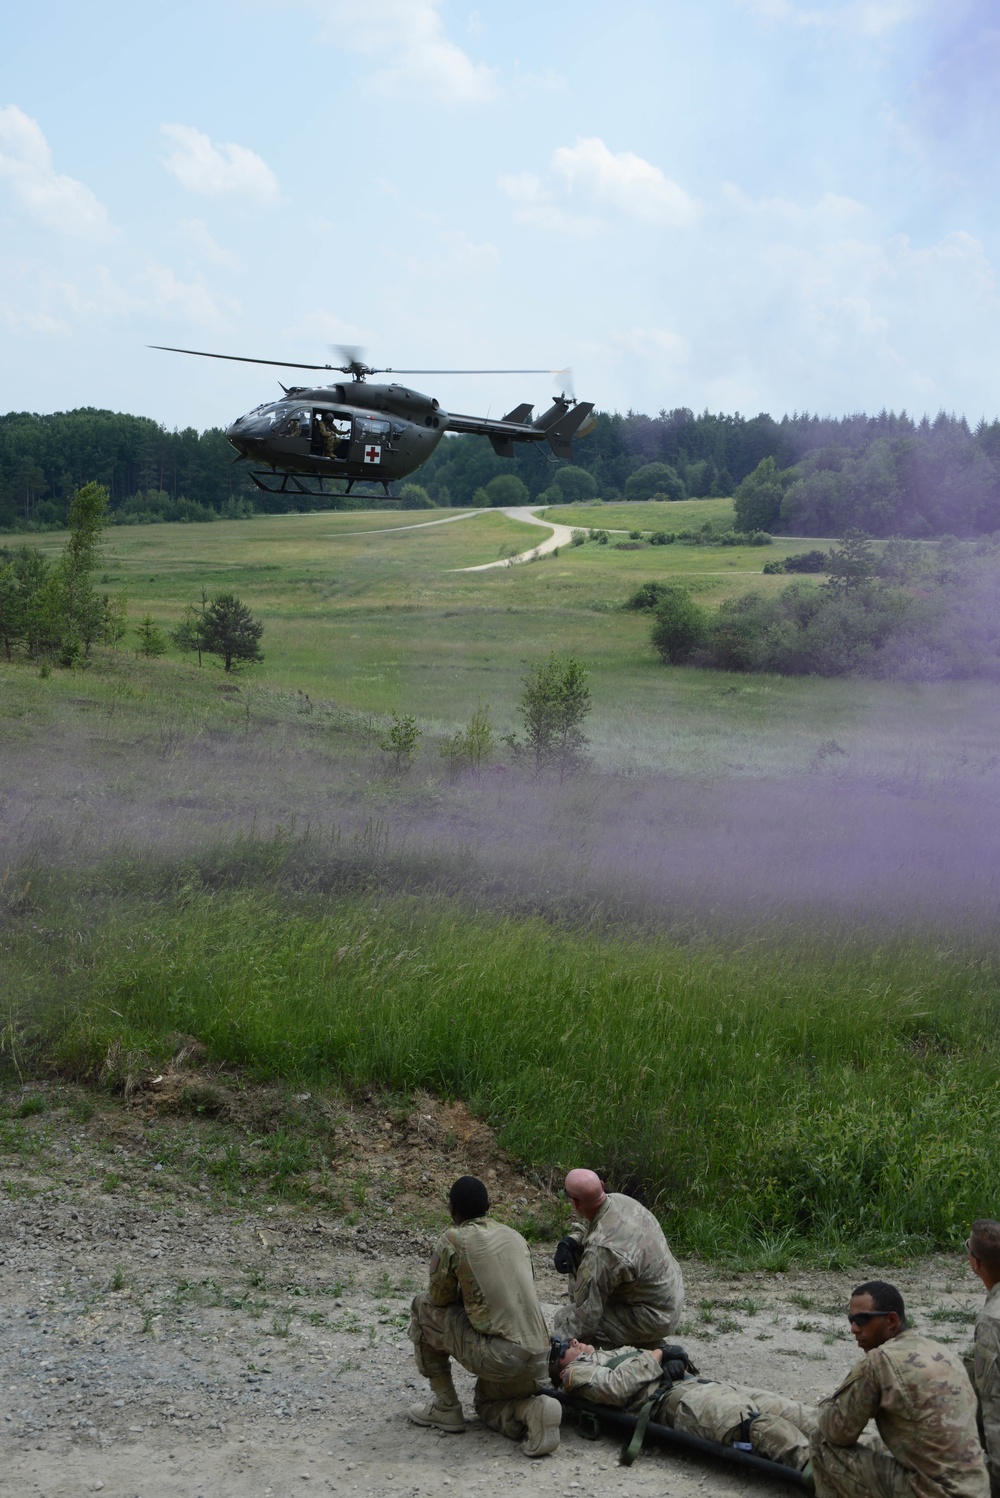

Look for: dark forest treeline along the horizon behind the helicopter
[0,407,1000,538]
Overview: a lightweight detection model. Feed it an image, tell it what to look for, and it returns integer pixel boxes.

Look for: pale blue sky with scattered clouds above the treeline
[0,0,1000,430]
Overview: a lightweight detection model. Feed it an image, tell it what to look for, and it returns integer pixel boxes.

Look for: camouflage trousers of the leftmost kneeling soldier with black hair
[409,1293,548,1441]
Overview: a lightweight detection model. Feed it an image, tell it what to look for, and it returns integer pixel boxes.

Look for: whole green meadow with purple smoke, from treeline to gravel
[0,502,1000,1267]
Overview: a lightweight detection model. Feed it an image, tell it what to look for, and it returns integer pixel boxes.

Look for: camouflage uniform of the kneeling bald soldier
[552,1191,684,1347]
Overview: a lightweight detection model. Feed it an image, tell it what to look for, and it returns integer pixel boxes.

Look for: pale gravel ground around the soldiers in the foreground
[0,1090,979,1498]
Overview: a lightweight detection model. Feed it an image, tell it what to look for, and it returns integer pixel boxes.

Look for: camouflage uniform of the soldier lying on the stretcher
[563,1347,816,1471]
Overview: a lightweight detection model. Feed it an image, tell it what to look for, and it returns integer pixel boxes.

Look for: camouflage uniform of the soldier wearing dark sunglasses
[811,1332,990,1498]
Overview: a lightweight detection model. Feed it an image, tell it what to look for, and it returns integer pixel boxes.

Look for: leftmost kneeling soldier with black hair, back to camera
[407,1176,563,1456]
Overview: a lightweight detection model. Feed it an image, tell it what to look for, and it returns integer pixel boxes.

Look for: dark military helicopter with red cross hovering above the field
[150,343,594,497]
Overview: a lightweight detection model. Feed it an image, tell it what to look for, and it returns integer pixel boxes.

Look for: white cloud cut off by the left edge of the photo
[0,105,111,240]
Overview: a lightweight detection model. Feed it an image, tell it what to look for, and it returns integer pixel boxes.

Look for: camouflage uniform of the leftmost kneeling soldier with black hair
[410,1218,548,1441]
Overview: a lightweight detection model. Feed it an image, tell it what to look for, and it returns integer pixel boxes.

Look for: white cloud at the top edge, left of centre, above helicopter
[305,0,497,103]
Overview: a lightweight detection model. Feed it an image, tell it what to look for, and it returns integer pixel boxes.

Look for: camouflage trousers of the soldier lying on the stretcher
[653,1378,817,1473]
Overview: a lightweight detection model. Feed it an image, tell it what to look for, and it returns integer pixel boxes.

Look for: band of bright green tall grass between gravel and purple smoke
[4,866,1000,1264]
